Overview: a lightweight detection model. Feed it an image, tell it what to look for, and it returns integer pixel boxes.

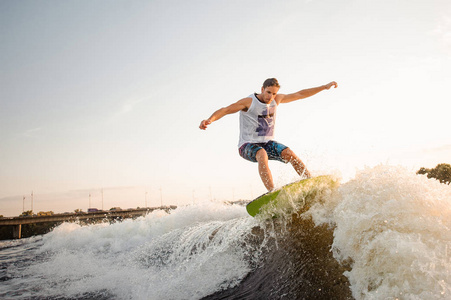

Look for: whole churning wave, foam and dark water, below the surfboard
[0,166,451,299]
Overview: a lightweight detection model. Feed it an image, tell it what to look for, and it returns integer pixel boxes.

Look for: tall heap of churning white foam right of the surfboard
[311,165,451,299]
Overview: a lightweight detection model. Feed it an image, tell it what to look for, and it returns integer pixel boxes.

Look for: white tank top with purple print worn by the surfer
[238,94,277,147]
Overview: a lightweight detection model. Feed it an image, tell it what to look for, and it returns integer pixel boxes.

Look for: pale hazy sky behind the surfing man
[0,0,451,216]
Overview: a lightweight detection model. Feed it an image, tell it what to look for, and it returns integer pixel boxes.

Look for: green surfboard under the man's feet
[246,175,337,217]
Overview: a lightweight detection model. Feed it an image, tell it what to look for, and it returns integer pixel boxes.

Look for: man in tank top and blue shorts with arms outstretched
[199,78,337,191]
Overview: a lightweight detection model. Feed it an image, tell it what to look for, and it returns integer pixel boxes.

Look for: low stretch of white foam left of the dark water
[23,202,256,299]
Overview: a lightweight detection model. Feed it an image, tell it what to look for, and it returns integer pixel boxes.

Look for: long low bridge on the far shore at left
[0,205,177,239]
